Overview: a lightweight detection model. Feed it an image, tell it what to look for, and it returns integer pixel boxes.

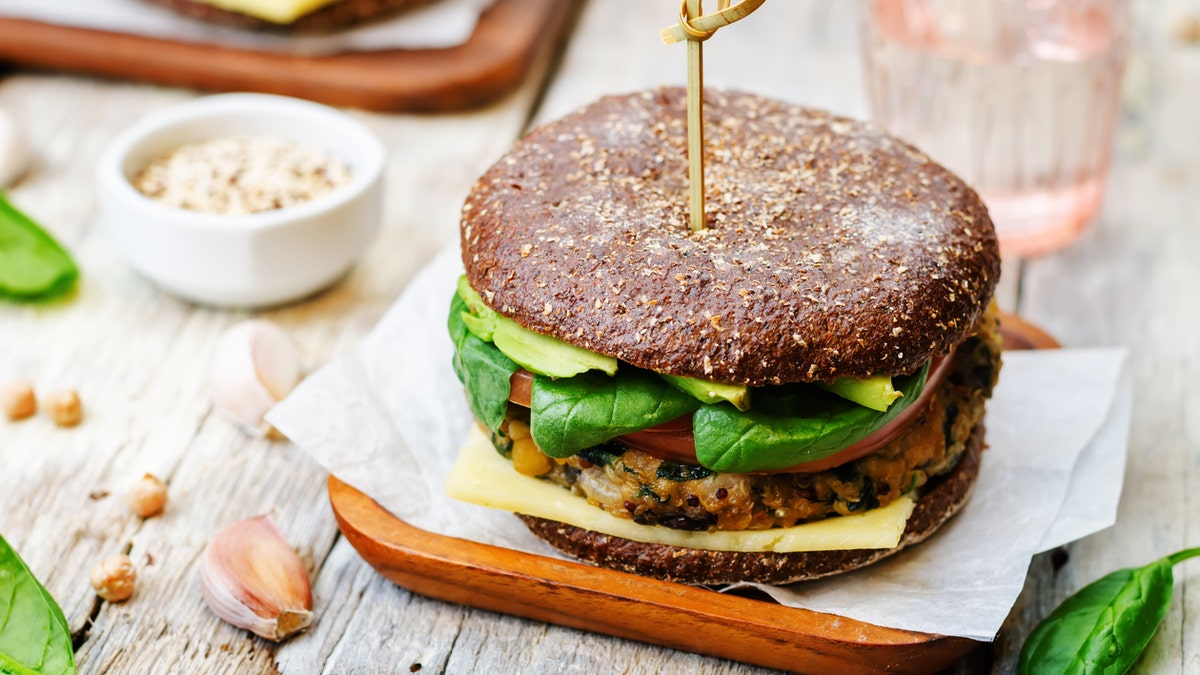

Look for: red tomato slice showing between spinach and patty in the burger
[509,352,954,473]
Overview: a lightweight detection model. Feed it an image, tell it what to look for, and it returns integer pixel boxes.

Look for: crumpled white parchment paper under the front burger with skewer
[268,250,1130,640]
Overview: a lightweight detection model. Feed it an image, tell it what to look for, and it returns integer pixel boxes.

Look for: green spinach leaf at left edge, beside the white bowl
[0,192,79,300]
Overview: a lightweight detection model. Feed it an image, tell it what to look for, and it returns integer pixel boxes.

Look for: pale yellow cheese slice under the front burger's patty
[445,426,913,552]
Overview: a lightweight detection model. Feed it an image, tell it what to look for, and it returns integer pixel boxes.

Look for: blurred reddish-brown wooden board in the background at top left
[0,0,575,112]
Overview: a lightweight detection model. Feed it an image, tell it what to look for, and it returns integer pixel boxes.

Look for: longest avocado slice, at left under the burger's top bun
[458,275,617,377]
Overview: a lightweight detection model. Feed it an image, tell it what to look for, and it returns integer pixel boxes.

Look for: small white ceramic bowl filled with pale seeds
[96,94,384,307]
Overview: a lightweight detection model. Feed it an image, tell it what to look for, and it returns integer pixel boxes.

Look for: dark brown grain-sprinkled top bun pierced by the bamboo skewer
[462,88,1000,386]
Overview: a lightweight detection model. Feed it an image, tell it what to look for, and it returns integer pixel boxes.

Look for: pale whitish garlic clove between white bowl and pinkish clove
[212,319,304,436]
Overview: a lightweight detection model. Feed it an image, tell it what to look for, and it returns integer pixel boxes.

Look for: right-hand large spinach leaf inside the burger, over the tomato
[692,364,929,473]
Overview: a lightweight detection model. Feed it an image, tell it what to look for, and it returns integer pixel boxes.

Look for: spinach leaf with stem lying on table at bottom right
[1019,549,1200,675]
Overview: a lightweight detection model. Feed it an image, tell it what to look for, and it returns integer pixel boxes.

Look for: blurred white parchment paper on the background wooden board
[0,0,493,55]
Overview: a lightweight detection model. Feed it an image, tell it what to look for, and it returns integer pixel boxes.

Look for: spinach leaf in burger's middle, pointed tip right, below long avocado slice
[529,369,701,458]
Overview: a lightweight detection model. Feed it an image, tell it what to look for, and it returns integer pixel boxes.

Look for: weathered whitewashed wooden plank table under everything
[0,0,1200,673]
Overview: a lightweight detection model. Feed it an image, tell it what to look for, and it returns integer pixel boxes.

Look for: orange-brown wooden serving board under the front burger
[329,315,1058,674]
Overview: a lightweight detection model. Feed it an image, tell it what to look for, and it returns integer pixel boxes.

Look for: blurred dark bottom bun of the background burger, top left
[150,0,433,32]
